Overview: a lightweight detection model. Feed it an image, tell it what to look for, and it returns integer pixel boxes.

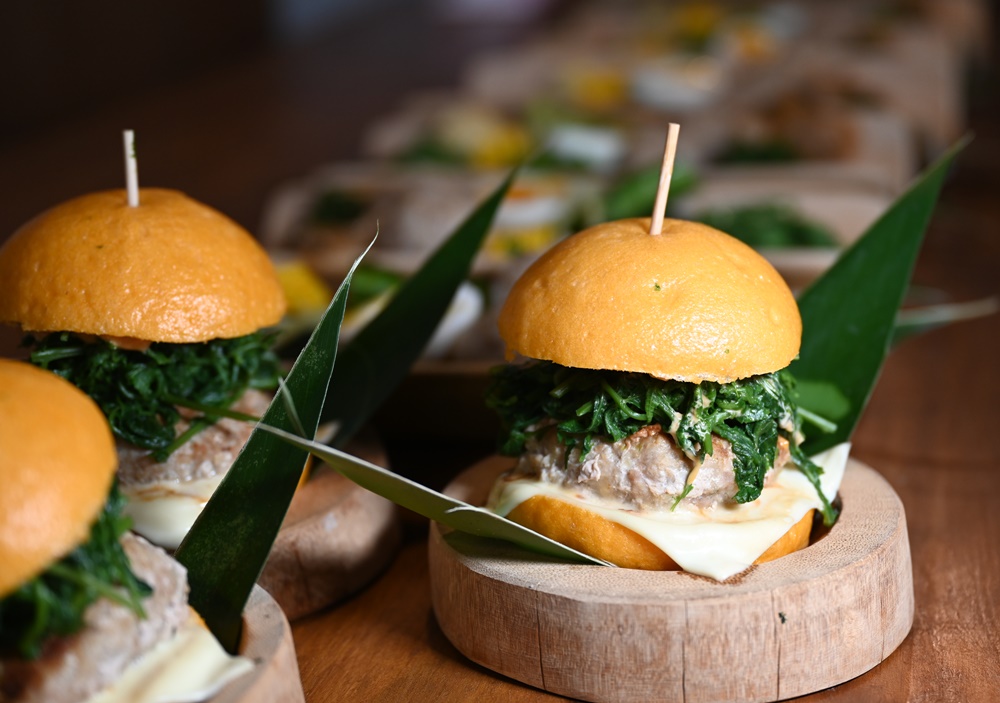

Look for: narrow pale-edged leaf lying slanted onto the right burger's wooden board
[258,423,609,566]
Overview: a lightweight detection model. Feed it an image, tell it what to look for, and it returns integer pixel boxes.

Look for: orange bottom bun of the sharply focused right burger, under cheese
[507,496,815,571]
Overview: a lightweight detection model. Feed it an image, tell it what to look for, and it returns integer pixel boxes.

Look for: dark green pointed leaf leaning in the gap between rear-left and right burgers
[323,169,517,446]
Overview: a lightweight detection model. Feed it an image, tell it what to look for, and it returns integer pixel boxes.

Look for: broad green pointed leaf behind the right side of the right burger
[791,138,969,454]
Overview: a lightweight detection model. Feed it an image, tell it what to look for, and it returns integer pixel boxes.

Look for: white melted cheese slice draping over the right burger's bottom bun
[493,444,850,581]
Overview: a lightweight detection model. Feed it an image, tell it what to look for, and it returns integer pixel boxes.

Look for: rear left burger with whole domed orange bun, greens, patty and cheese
[0,188,285,548]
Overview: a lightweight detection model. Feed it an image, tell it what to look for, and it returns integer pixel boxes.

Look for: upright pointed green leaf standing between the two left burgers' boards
[175,245,370,652]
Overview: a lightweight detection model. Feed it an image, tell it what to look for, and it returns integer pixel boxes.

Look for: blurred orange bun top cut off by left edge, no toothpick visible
[0,359,118,598]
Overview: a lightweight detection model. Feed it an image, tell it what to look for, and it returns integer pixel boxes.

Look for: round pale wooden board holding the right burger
[428,457,913,703]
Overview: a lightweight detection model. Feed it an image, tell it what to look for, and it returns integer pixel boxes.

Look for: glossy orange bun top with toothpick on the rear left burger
[0,188,285,342]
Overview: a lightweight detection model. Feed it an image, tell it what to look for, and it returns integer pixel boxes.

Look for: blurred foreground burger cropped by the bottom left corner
[0,359,251,703]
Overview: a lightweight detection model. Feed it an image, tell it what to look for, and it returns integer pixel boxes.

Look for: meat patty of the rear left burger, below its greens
[118,390,271,488]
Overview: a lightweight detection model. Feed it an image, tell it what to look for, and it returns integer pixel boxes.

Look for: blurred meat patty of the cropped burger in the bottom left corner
[0,534,188,703]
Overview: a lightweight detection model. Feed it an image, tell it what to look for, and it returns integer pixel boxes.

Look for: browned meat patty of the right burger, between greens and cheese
[512,425,789,510]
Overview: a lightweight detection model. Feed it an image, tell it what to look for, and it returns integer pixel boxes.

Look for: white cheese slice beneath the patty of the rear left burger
[122,474,225,549]
